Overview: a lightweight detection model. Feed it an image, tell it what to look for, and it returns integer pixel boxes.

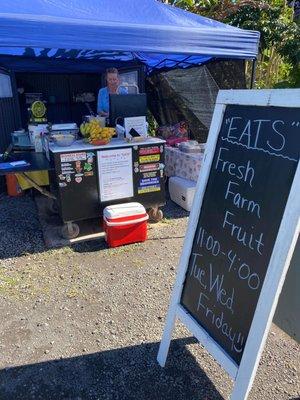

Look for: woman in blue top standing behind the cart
[97,68,127,117]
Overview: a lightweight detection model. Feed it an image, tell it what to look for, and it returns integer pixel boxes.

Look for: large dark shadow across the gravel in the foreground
[0,338,223,400]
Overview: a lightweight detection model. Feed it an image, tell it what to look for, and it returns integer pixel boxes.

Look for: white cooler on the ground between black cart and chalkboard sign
[169,176,197,211]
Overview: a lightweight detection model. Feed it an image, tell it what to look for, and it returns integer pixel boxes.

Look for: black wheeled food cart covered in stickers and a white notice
[48,137,165,237]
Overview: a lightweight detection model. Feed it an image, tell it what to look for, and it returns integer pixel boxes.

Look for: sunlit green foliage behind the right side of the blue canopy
[169,0,300,87]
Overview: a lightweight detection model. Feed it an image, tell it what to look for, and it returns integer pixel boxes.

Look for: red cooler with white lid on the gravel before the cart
[103,203,149,247]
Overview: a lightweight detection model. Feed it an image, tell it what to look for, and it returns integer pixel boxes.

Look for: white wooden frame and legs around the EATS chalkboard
[157,89,300,400]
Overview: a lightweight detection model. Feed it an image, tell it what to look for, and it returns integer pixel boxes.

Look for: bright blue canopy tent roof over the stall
[0,0,259,72]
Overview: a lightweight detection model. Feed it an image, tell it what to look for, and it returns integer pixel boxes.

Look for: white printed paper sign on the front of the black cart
[97,147,133,202]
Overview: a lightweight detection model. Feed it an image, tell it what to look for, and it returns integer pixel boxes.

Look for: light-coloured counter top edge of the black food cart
[49,137,165,153]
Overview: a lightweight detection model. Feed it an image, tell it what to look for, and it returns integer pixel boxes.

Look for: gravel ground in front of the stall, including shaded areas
[0,196,300,400]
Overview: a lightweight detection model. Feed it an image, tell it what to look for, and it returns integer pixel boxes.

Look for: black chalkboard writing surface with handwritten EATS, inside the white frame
[180,105,300,365]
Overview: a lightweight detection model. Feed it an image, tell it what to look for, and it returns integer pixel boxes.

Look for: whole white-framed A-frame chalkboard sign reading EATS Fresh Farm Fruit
[158,90,300,400]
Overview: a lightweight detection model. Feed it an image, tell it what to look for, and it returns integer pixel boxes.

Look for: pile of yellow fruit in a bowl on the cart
[80,118,115,145]
